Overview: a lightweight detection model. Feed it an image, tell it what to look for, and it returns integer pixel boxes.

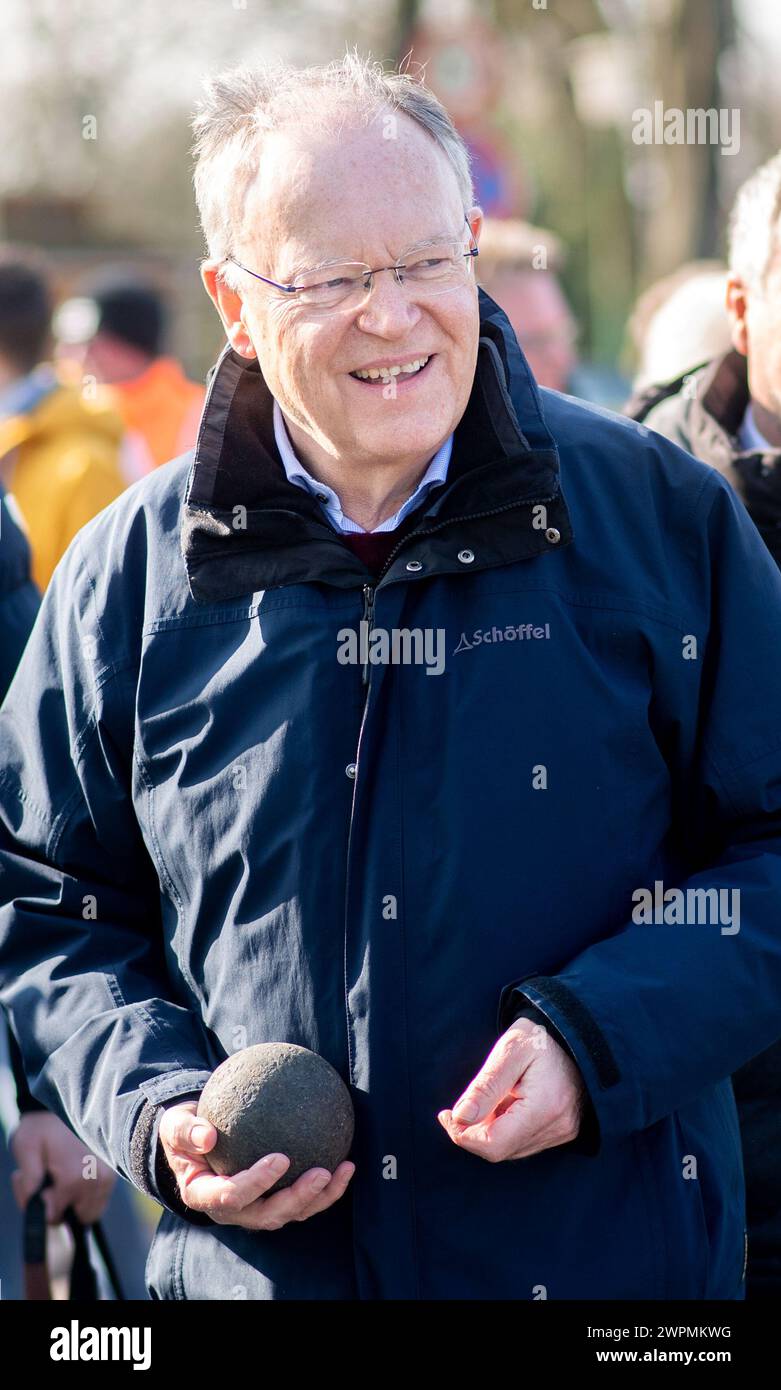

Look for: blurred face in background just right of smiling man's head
[478,263,577,391]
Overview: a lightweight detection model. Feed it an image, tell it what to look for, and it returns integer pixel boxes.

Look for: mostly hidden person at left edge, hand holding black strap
[0,488,151,1301]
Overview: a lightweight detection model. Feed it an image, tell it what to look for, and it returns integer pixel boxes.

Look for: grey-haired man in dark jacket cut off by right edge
[627,153,781,1297]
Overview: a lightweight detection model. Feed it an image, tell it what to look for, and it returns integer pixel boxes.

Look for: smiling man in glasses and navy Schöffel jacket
[0,57,781,1300]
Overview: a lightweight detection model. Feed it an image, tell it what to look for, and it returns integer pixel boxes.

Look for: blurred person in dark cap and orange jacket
[56,270,206,482]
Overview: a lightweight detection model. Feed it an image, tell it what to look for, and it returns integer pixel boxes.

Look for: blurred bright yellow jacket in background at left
[0,384,125,589]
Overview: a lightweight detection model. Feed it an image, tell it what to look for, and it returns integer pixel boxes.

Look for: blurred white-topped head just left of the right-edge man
[630,260,732,393]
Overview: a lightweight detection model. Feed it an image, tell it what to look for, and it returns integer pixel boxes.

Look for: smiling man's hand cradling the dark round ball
[158,1101,356,1230]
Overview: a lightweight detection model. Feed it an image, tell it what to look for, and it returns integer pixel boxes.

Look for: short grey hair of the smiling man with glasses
[193,51,474,284]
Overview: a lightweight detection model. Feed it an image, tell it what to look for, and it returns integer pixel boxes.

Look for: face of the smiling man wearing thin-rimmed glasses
[207,115,481,478]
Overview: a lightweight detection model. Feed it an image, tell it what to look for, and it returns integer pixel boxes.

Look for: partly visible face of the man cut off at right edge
[727,245,781,448]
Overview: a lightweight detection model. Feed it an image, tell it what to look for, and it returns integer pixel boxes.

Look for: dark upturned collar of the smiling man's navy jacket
[181,289,573,603]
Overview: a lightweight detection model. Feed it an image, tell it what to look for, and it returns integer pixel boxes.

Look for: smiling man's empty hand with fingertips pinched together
[436,1019,585,1163]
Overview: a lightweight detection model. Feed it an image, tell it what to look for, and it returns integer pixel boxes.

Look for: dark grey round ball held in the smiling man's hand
[197,1043,354,1195]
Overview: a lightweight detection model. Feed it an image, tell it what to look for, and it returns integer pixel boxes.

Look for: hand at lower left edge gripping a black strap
[11,1111,117,1226]
